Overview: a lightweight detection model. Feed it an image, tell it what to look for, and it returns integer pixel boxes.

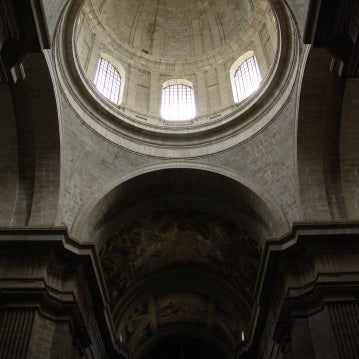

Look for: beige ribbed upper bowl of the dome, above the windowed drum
[91,0,260,60]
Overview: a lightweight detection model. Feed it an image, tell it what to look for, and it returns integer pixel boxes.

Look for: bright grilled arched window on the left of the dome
[94,58,121,104]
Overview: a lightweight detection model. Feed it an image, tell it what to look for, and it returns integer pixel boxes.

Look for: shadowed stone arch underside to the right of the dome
[297,48,347,220]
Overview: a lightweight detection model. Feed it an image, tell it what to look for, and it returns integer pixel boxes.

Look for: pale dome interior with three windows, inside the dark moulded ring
[71,0,286,142]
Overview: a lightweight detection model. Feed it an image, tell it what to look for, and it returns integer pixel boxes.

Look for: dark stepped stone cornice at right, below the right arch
[248,221,359,356]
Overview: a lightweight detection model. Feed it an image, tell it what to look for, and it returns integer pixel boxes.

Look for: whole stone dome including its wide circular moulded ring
[57,0,298,158]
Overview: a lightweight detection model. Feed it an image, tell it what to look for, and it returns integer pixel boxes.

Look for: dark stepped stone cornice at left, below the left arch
[0,227,122,358]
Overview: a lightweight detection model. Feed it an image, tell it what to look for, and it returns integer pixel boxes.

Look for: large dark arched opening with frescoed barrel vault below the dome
[71,168,286,358]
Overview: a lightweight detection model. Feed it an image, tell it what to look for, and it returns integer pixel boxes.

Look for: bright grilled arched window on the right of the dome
[231,51,262,103]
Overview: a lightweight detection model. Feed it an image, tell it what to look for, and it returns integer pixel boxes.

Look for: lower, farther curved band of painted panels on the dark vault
[120,292,243,353]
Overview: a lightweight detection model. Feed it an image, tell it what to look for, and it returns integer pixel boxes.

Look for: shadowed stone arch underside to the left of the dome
[0,53,61,226]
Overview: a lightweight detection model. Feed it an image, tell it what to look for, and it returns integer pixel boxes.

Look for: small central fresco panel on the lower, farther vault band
[156,293,208,325]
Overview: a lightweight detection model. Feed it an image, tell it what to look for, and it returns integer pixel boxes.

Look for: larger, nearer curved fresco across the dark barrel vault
[102,211,259,300]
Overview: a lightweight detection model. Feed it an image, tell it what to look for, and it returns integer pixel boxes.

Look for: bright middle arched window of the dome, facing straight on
[161,80,196,121]
